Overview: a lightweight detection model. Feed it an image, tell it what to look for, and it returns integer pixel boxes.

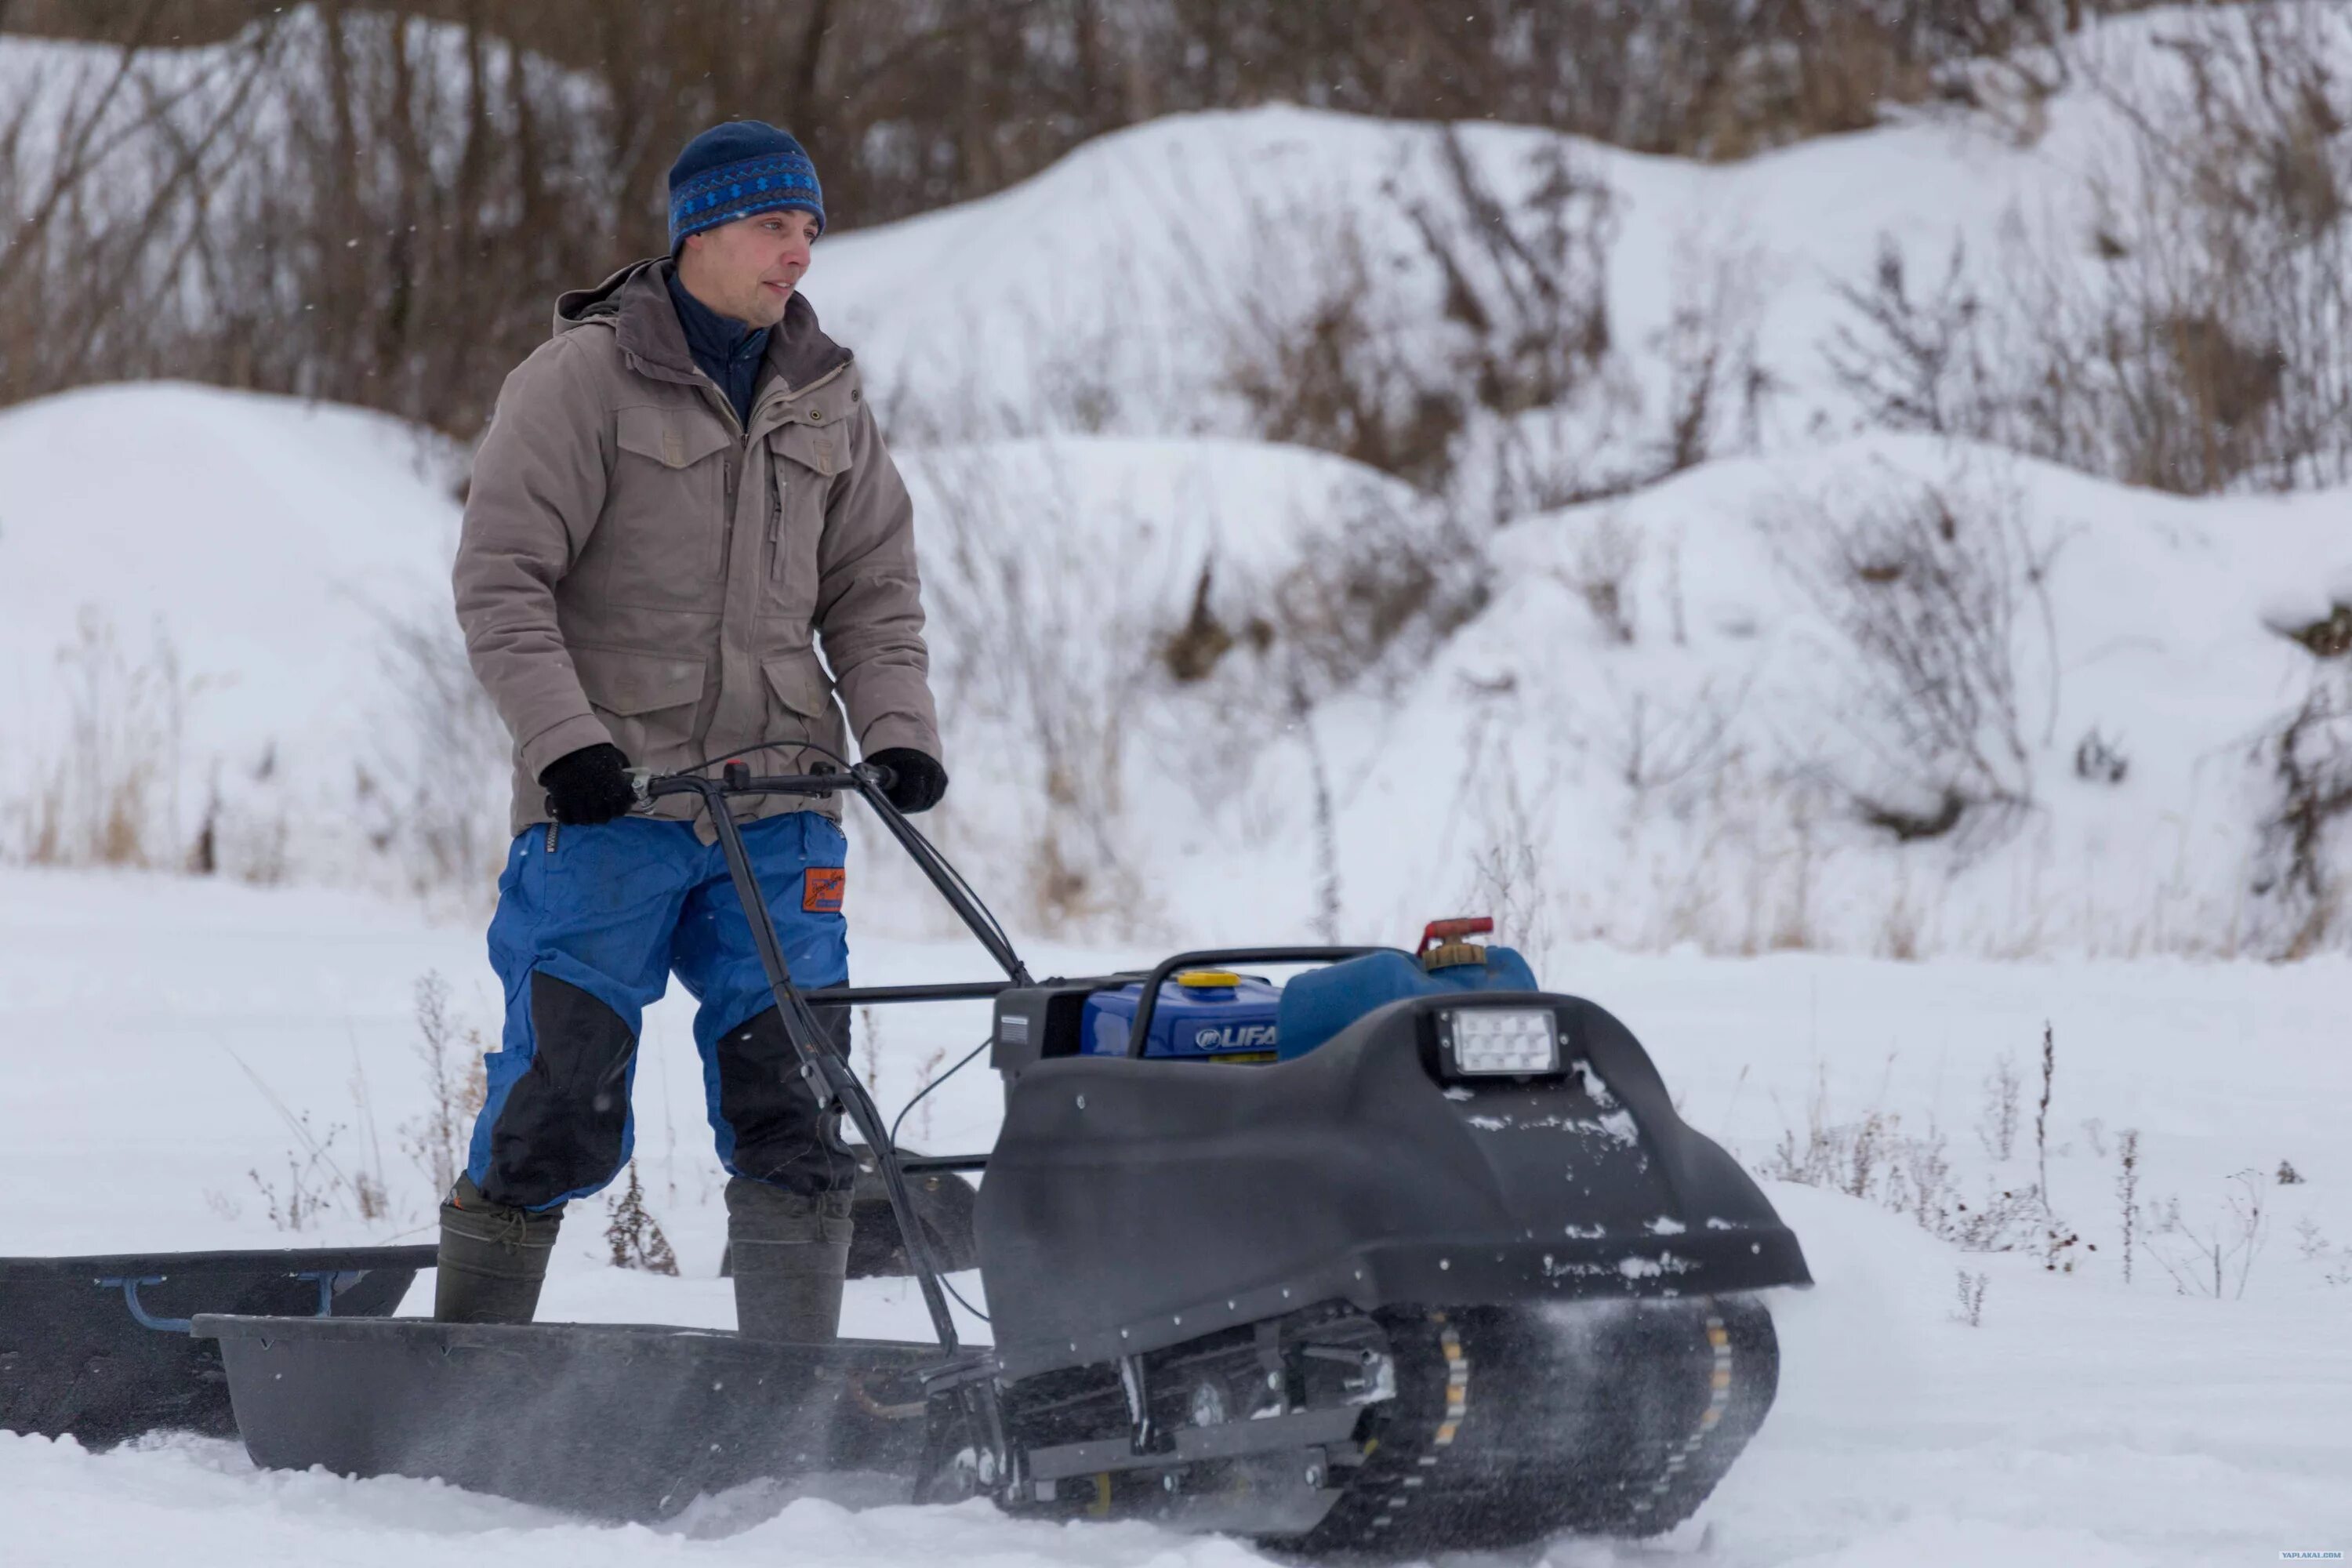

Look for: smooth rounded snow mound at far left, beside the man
[0,383,459,877]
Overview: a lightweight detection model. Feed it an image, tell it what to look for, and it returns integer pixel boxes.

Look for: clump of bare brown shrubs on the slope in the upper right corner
[1823,5,2352,496]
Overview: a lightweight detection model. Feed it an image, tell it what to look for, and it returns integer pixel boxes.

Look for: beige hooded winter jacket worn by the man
[456,261,941,839]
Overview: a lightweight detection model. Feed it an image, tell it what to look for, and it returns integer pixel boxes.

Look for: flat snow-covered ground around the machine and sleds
[0,872,2352,1568]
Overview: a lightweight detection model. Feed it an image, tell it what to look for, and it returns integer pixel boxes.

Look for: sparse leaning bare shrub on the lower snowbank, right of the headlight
[1766,460,2056,851]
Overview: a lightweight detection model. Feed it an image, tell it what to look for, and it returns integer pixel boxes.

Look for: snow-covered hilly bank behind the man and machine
[0,14,2352,954]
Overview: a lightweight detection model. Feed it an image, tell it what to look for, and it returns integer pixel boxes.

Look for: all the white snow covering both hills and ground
[0,14,2352,1568]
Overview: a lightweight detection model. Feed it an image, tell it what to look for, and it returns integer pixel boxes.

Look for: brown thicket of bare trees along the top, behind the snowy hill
[0,0,2183,433]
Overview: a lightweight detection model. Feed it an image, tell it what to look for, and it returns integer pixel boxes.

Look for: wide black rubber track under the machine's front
[1265,1295,1778,1556]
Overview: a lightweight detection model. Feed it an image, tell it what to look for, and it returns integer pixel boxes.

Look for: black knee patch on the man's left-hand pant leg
[482,973,637,1208]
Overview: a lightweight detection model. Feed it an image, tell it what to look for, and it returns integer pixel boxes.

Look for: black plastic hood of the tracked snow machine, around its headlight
[974,992,1811,1377]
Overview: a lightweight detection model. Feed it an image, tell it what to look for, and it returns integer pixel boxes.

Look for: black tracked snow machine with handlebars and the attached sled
[195,764,1811,1556]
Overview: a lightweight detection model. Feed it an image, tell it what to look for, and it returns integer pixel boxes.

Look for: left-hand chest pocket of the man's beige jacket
[597,407,734,609]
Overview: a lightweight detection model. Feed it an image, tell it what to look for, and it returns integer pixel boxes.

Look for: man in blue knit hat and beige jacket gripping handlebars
[449,120,948,1340]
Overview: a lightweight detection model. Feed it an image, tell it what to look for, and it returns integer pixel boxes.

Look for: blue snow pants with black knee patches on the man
[466,811,856,1210]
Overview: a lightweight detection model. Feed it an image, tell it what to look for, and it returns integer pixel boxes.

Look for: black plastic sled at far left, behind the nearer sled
[0,1246,433,1448]
